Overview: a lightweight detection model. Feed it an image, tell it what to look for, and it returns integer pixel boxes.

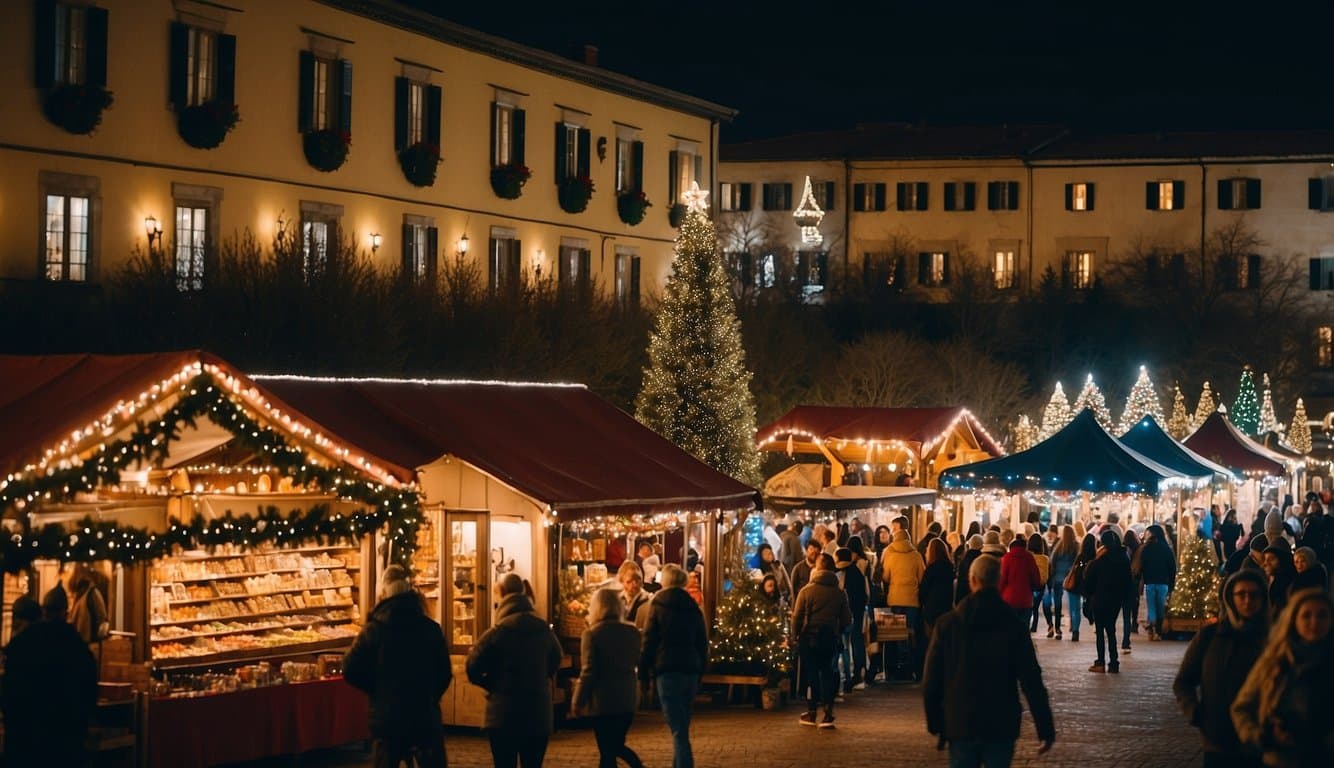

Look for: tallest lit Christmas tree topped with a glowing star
[635,187,762,487]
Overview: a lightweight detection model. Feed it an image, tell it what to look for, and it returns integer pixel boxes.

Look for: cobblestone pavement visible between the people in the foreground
[232,621,1201,768]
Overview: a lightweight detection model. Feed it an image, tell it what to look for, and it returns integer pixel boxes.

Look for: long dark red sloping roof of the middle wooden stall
[255,376,756,519]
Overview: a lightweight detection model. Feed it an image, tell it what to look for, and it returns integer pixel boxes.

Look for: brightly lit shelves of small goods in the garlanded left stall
[148,545,360,669]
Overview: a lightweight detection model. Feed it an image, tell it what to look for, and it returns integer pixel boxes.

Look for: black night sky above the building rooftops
[410,0,1334,141]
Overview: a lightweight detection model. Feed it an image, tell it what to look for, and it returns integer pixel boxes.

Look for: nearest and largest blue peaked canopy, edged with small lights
[940,408,1182,493]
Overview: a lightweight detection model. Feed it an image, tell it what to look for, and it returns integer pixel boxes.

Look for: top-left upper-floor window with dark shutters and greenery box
[33,1,113,136]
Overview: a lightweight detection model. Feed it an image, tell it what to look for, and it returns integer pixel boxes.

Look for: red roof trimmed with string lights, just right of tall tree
[755,405,1005,456]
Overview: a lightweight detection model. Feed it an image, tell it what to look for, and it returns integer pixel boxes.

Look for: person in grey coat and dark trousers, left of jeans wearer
[572,589,643,768]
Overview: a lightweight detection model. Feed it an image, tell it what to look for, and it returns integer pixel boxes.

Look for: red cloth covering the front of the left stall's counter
[148,677,370,768]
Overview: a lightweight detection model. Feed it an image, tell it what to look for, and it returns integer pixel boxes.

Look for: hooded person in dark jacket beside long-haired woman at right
[1171,569,1269,768]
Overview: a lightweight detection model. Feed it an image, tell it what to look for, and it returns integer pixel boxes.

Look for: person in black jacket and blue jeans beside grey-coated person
[639,565,708,768]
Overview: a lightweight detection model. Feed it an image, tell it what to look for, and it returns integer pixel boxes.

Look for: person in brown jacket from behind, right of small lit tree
[792,552,853,728]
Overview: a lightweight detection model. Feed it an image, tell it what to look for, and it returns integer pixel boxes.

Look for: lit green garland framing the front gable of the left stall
[0,373,422,572]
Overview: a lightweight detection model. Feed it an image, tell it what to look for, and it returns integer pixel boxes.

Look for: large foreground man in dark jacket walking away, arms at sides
[922,556,1057,767]
